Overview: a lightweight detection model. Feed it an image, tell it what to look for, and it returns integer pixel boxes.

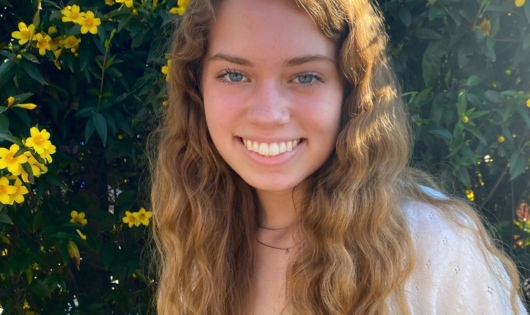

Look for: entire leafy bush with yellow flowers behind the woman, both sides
[0,0,530,314]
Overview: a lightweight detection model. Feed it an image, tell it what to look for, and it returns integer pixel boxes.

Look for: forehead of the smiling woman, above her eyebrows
[208,0,335,60]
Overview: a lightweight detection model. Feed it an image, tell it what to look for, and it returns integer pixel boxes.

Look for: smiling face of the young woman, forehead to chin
[202,0,343,191]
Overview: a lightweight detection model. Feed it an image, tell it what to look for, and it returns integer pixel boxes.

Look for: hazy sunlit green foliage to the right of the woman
[380,0,530,294]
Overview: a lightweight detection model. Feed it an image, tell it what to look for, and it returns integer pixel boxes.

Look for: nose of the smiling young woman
[247,80,291,128]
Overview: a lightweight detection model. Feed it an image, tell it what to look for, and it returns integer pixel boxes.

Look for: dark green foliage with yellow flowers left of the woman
[0,0,185,315]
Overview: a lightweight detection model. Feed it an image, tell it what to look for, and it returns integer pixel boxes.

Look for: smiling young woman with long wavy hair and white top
[148,0,524,315]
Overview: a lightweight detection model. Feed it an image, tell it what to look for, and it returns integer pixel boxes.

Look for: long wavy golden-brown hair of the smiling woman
[147,0,518,315]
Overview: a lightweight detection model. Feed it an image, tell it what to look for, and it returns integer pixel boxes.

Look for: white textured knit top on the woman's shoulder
[403,200,528,315]
